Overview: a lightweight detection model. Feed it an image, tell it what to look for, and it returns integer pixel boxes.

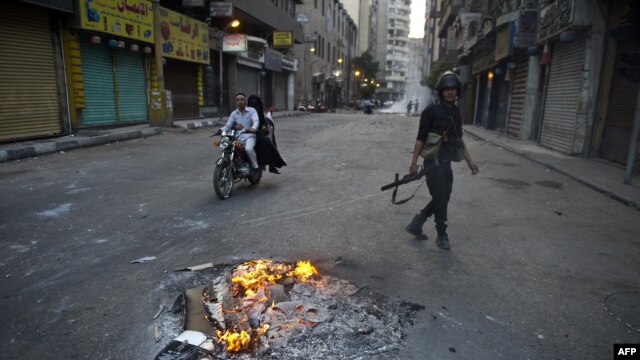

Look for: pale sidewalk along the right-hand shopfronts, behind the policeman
[464,125,640,210]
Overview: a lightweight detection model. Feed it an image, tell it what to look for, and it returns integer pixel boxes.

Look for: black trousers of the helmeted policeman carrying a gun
[420,160,453,235]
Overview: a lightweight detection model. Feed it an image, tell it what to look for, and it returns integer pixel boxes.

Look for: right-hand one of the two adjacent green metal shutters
[115,50,147,123]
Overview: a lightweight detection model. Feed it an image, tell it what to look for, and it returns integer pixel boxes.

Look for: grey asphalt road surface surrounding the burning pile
[0,114,640,359]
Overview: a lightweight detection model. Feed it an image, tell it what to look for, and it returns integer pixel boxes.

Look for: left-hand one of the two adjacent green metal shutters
[80,36,118,126]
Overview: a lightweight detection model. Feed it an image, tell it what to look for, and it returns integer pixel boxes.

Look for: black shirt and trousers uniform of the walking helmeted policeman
[414,103,462,236]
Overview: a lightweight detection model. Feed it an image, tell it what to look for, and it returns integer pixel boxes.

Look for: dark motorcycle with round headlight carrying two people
[212,129,262,200]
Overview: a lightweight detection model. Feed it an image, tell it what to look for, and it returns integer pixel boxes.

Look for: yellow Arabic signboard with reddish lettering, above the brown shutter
[160,7,210,64]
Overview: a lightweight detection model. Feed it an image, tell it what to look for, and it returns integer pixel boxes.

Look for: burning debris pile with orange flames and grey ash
[156,260,420,360]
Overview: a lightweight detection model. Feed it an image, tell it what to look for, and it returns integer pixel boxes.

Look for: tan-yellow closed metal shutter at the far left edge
[0,2,62,141]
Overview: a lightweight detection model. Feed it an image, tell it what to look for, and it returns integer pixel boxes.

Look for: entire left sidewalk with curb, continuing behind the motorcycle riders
[0,111,307,162]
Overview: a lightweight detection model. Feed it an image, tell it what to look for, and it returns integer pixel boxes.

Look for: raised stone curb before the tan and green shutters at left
[0,127,164,162]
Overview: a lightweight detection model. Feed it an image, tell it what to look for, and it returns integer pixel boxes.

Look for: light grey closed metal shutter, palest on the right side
[540,36,585,153]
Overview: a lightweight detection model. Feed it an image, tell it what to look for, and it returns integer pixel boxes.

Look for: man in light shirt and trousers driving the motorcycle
[220,92,260,175]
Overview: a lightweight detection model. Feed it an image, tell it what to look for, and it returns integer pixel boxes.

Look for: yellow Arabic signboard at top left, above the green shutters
[79,0,153,43]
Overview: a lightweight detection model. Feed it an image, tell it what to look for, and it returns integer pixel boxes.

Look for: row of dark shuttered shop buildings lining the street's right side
[429,0,640,177]
